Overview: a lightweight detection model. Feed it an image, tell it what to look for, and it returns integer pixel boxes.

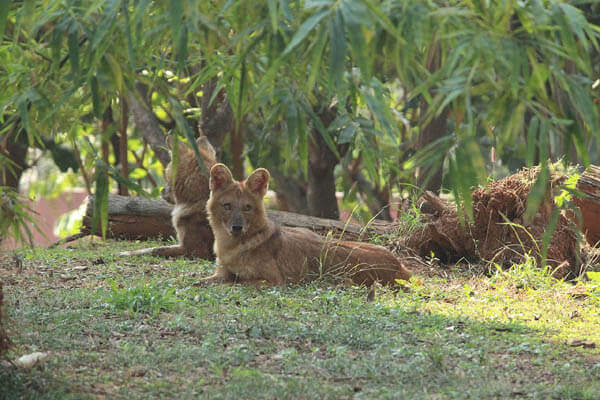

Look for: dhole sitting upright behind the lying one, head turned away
[120,136,216,259]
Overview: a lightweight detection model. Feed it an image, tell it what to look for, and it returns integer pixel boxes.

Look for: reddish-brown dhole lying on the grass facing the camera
[199,164,410,285]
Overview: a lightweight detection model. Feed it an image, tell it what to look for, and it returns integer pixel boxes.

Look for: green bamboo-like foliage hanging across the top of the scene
[0,0,600,241]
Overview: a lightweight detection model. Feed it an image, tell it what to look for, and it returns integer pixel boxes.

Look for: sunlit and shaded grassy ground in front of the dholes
[0,240,600,399]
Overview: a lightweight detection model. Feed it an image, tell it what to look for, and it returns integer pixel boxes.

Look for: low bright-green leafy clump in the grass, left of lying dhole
[105,282,178,316]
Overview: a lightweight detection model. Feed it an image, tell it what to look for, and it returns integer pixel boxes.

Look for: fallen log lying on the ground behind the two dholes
[81,194,395,240]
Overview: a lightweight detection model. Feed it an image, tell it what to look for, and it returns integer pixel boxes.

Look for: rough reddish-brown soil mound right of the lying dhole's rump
[407,168,579,278]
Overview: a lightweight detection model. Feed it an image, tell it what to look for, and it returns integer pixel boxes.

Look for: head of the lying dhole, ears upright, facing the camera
[206,164,270,237]
